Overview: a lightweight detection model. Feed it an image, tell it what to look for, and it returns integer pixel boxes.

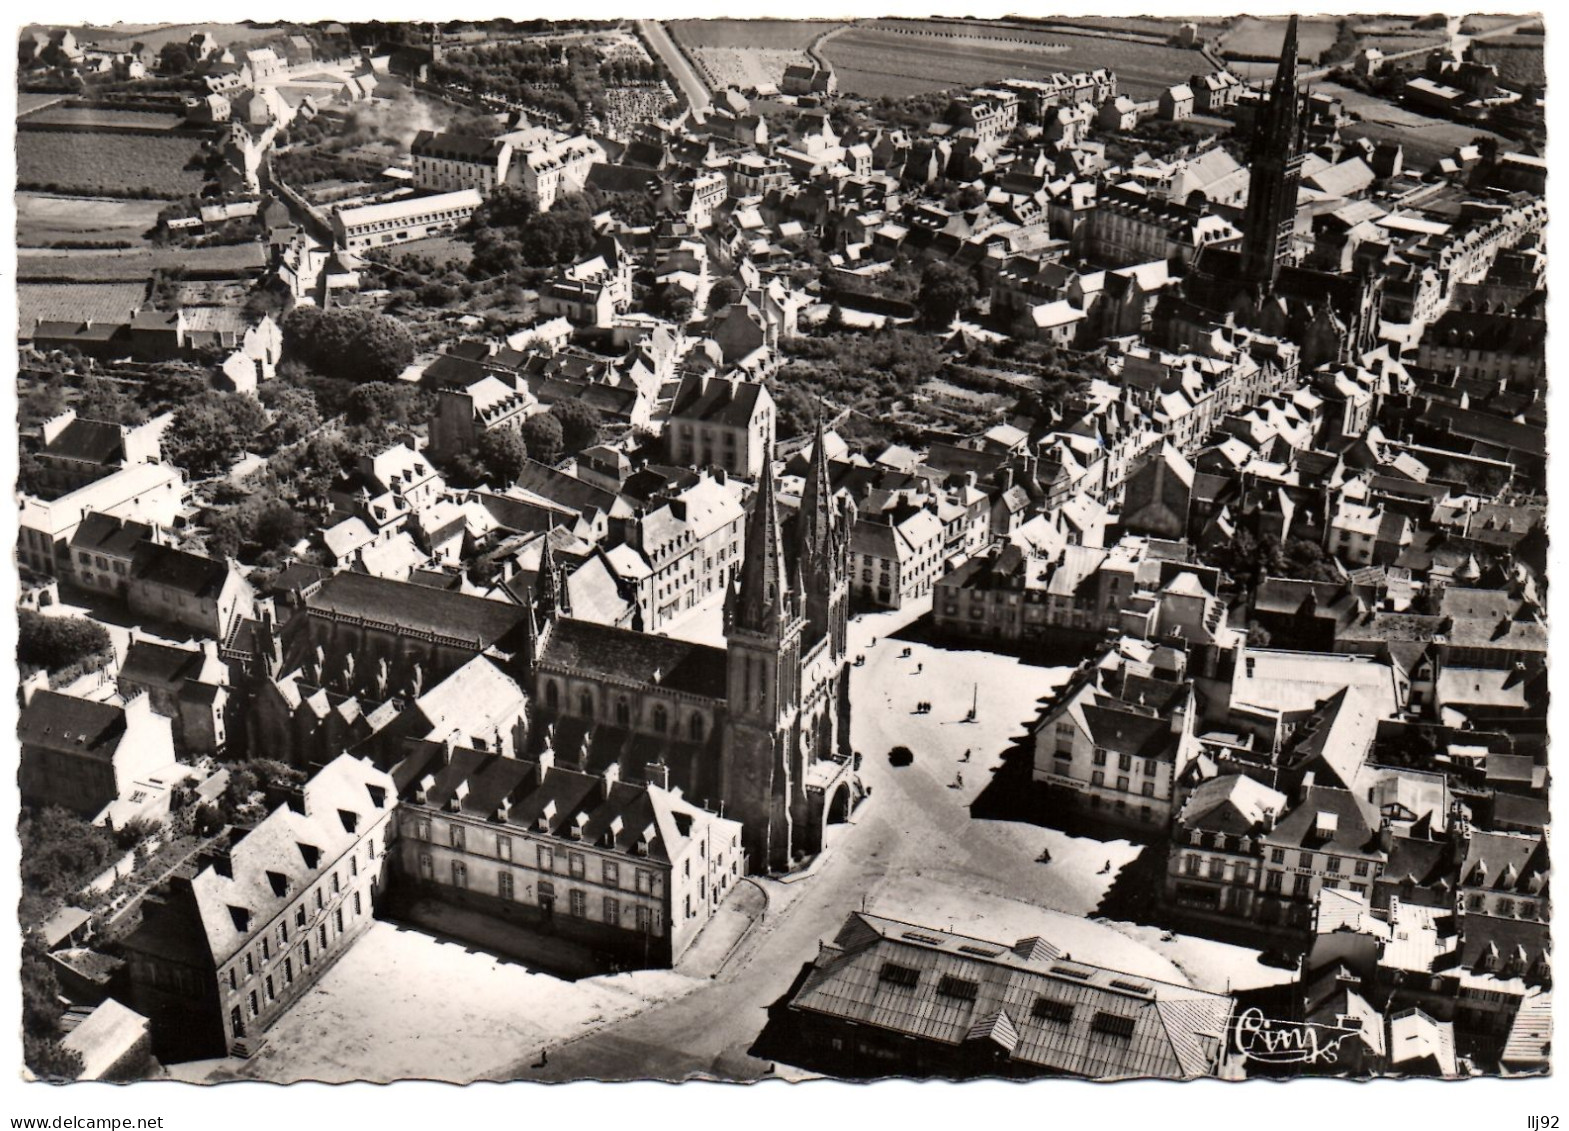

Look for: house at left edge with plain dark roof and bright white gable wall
[17,687,174,817]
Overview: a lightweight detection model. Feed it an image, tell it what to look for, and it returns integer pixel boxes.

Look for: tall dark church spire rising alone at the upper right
[1241,16,1302,290]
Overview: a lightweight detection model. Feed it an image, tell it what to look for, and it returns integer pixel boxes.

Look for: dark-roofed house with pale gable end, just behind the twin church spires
[665,373,777,478]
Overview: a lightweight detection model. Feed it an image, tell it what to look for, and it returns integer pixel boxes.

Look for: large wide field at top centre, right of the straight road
[822,20,1207,99]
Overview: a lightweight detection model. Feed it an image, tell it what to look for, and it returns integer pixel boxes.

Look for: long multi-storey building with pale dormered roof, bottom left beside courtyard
[121,755,397,1062]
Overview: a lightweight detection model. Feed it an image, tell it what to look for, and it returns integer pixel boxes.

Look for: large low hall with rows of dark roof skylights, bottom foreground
[786,911,1233,1081]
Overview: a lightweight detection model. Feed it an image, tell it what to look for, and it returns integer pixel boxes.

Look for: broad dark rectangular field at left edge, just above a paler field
[16,130,206,198]
